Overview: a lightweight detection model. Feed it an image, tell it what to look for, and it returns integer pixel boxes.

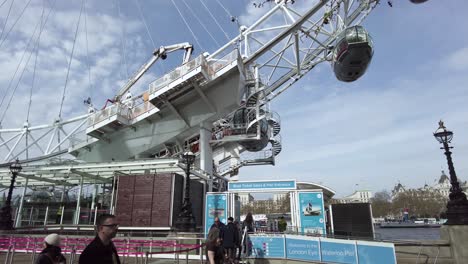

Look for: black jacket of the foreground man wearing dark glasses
[78,236,120,264]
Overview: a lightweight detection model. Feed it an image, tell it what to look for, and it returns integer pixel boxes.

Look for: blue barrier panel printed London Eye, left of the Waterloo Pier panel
[286,235,321,261]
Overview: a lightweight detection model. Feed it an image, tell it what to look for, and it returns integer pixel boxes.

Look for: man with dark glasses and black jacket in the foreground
[79,214,120,264]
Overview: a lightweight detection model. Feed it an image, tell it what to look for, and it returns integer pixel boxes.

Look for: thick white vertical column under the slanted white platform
[200,122,213,192]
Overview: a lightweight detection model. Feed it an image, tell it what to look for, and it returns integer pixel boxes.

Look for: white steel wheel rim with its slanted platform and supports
[0,0,379,190]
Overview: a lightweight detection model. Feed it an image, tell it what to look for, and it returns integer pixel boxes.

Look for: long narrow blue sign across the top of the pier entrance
[228,180,296,192]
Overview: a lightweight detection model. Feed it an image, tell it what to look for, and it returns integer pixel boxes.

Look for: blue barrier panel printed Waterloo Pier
[320,238,358,264]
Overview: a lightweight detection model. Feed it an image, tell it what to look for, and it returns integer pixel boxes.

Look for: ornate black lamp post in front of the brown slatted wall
[175,151,196,231]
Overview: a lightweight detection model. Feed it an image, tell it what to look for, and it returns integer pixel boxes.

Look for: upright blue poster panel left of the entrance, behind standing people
[205,193,229,237]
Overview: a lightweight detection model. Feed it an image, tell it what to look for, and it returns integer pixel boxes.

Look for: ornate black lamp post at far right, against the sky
[434,120,468,225]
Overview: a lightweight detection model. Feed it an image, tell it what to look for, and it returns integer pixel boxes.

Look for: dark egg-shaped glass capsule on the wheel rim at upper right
[333,26,374,82]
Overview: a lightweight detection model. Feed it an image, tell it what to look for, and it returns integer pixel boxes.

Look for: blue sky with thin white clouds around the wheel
[0,0,468,197]
